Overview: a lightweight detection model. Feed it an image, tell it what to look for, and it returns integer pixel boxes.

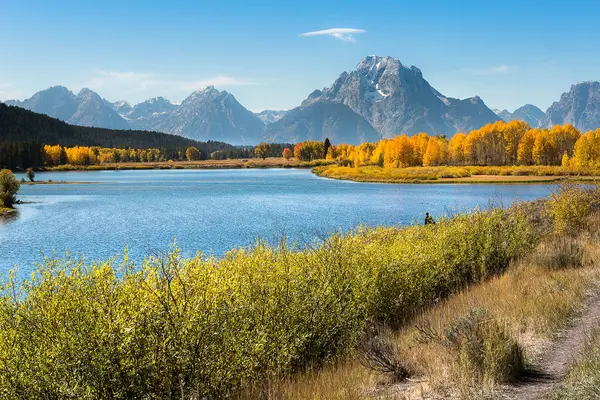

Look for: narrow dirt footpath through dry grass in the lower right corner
[502,291,600,400]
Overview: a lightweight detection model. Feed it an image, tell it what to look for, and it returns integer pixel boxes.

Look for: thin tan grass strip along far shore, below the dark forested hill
[45,157,334,171]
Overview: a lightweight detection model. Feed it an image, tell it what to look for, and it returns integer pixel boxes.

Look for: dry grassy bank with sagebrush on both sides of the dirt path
[270,233,600,399]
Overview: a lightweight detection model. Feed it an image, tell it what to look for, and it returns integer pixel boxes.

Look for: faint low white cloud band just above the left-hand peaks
[82,69,258,95]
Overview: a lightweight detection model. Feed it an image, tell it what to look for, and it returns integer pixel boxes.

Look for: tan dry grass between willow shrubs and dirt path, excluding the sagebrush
[263,214,600,399]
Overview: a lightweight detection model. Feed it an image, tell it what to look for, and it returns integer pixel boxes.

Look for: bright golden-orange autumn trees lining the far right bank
[332,121,600,168]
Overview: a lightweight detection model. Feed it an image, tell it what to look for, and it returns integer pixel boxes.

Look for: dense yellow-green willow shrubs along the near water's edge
[0,205,536,399]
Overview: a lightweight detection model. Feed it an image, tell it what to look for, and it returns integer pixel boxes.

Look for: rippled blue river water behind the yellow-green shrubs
[0,169,549,274]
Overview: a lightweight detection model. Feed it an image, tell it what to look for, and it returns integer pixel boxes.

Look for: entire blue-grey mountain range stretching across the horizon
[6,56,600,145]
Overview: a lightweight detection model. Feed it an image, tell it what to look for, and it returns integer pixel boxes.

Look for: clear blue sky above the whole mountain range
[0,0,600,111]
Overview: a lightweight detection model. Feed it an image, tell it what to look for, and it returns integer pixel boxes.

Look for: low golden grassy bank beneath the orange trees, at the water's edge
[313,165,600,183]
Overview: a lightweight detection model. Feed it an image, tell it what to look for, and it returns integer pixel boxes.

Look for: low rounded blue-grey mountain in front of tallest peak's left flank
[265,102,381,144]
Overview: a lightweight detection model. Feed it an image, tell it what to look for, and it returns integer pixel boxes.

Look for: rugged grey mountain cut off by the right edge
[543,82,600,132]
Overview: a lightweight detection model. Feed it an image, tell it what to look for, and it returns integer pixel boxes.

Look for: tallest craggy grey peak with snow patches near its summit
[302,56,499,136]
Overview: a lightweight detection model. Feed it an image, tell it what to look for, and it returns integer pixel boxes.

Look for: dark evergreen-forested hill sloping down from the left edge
[0,103,234,154]
